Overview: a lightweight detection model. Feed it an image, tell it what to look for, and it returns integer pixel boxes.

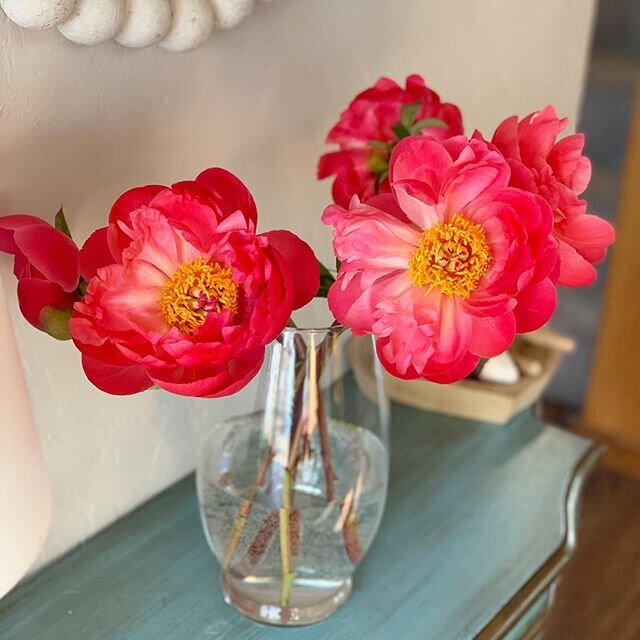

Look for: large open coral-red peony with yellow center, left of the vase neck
[71,169,319,397]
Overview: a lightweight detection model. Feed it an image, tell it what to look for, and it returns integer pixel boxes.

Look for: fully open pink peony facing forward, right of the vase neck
[323,136,558,383]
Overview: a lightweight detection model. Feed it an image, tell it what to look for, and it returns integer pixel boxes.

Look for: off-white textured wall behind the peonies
[0,0,594,561]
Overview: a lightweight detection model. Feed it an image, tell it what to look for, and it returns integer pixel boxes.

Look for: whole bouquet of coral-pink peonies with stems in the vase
[0,75,614,606]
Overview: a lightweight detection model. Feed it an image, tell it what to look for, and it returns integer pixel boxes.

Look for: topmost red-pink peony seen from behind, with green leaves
[318,75,462,207]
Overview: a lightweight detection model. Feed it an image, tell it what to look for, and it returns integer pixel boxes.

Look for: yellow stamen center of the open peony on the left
[159,258,238,335]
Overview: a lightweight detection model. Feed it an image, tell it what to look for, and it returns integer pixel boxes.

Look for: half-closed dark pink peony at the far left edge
[0,214,80,340]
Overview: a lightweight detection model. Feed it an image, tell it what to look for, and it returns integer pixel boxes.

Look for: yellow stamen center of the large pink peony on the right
[409,214,491,298]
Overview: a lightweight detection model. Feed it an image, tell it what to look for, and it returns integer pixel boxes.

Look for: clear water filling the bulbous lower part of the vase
[198,413,388,624]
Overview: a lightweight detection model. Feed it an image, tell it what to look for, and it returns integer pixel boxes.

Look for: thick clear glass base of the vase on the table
[220,571,351,627]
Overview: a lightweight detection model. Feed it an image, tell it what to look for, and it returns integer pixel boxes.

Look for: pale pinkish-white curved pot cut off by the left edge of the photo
[0,280,51,598]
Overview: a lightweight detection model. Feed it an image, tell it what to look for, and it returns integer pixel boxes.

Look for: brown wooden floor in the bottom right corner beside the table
[544,467,640,640]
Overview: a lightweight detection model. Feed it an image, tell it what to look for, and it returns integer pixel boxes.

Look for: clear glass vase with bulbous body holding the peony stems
[197,326,389,625]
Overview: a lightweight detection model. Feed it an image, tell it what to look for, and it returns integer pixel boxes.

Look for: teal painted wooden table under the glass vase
[0,406,598,640]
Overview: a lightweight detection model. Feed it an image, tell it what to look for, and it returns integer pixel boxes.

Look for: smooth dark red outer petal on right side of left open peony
[262,231,320,309]
